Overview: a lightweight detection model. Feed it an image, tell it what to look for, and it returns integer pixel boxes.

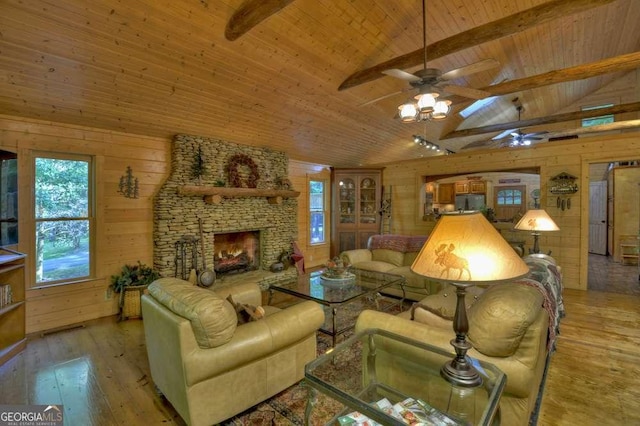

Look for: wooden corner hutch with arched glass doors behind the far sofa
[331,169,382,256]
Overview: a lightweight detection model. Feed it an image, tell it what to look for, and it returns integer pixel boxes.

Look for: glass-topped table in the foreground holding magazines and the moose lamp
[304,329,506,426]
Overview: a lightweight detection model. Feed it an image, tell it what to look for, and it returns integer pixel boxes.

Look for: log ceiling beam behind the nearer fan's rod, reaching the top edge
[338,0,615,90]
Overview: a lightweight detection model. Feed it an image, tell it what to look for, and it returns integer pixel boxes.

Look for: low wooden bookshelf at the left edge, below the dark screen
[0,247,27,365]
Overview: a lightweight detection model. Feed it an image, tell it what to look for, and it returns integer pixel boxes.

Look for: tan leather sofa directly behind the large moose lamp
[356,283,549,426]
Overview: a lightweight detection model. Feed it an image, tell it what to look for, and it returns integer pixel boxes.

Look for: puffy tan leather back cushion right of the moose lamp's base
[468,283,544,357]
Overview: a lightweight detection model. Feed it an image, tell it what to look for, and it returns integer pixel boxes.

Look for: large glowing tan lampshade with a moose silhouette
[411,212,529,285]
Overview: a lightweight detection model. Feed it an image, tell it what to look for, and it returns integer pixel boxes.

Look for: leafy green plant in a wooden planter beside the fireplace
[111,261,160,320]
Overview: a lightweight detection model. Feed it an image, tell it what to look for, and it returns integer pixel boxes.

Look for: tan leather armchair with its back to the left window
[142,278,324,425]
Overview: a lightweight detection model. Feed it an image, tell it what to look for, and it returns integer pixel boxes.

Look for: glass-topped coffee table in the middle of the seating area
[268,269,406,347]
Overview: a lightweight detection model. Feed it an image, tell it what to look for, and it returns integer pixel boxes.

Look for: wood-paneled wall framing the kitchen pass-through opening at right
[384,133,640,290]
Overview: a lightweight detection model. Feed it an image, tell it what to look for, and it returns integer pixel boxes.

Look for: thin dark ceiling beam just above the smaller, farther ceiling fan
[440,102,640,140]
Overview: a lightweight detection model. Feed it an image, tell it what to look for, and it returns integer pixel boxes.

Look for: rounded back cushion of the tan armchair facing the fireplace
[149,278,238,348]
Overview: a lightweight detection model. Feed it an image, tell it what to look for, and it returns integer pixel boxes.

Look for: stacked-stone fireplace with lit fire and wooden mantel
[153,135,297,284]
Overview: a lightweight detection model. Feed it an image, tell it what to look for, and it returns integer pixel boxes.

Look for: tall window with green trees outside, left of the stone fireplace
[33,154,93,285]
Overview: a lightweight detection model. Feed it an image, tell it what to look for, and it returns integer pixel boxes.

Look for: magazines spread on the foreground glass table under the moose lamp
[338,398,470,426]
